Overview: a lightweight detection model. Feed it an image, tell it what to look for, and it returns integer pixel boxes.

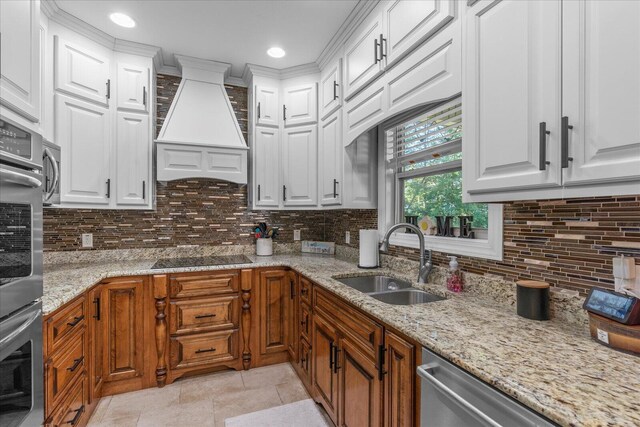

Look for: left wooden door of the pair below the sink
[311,314,338,424]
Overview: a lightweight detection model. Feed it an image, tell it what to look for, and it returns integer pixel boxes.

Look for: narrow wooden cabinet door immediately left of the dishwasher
[384,331,416,427]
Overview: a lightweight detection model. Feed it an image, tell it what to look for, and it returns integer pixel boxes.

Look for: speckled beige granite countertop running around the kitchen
[43,254,640,426]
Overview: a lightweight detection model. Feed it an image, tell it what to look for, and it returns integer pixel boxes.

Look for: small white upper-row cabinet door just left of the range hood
[117,62,149,112]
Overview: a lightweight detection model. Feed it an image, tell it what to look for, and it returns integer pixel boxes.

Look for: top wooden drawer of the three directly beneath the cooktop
[169,271,240,298]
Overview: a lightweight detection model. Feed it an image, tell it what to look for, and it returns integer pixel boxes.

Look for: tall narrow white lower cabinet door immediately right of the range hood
[253,127,280,207]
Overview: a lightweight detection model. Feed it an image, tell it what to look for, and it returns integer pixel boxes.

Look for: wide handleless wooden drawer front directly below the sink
[314,287,383,360]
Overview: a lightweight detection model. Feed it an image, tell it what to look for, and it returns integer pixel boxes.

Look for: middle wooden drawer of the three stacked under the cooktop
[170,296,238,334]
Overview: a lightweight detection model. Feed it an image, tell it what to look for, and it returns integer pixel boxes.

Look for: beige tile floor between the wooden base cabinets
[89,363,316,427]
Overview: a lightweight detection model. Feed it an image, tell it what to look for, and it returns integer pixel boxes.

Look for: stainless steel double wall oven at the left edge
[0,116,44,427]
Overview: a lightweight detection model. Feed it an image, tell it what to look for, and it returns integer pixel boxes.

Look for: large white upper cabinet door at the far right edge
[562,0,640,188]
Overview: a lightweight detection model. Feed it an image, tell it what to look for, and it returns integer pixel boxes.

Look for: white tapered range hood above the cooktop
[156,55,249,184]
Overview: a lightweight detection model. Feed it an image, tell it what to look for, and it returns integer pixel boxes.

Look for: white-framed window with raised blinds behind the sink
[380,97,502,259]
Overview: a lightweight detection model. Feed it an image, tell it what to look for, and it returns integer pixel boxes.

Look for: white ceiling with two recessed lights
[56,0,358,77]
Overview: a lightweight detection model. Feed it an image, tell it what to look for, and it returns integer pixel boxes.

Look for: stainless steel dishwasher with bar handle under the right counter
[418,348,556,427]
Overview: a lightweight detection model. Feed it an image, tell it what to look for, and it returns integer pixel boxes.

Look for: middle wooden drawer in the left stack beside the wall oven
[46,326,87,407]
